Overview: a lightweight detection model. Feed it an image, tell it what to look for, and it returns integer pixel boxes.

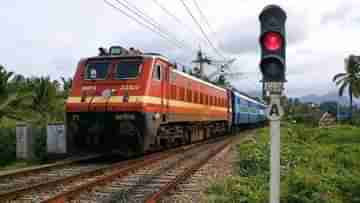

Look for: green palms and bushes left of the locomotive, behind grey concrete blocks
[0,65,72,166]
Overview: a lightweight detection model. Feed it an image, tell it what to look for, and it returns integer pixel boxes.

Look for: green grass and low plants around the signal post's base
[207,124,360,203]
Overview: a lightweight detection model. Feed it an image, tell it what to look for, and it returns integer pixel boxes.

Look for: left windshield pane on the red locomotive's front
[85,62,110,80]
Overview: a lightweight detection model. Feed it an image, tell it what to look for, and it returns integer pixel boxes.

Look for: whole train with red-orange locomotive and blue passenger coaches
[65,46,266,155]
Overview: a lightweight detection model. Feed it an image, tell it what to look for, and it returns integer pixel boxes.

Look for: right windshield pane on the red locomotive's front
[116,61,141,80]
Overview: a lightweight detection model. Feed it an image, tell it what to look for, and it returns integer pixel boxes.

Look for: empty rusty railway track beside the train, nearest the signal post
[42,138,232,203]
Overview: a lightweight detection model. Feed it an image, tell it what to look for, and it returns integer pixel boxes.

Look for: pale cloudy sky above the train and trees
[0,0,360,96]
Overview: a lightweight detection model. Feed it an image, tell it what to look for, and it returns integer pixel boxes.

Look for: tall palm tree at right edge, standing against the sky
[333,55,360,118]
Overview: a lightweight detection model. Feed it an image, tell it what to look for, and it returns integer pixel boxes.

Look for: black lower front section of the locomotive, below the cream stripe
[66,112,144,154]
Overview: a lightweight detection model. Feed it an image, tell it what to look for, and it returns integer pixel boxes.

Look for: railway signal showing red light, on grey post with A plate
[259,5,286,203]
